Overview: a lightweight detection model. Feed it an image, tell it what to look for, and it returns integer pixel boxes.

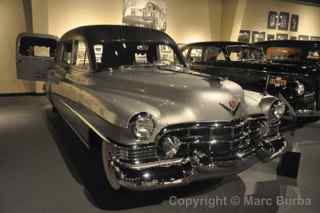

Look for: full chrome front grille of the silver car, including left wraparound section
[114,116,270,163]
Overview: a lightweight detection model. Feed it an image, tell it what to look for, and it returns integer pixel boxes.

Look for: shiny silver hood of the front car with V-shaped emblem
[88,68,247,127]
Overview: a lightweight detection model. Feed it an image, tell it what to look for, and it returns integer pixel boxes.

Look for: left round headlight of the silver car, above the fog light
[130,112,155,140]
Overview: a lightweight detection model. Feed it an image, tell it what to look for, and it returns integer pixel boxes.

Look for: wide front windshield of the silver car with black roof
[93,42,183,70]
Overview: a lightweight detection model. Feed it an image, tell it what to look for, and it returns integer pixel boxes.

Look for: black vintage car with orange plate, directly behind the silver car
[182,42,320,117]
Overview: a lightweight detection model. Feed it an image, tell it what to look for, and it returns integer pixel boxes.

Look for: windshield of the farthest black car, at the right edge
[267,47,320,62]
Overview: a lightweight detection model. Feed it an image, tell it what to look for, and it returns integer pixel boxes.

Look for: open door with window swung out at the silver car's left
[16,33,58,81]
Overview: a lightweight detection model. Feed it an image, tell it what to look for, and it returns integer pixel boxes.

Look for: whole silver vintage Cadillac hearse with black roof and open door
[17,26,287,191]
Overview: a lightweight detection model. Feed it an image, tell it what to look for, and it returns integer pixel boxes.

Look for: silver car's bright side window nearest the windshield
[73,41,89,68]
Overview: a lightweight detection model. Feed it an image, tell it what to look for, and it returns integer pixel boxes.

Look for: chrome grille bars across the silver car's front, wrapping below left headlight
[114,115,270,163]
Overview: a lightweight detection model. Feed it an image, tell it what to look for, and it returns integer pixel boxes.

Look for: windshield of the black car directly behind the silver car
[226,45,265,61]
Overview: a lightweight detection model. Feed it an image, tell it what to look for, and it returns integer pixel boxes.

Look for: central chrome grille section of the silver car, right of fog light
[158,117,258,157]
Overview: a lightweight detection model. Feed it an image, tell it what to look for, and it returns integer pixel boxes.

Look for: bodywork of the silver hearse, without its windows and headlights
[17,26,287,190]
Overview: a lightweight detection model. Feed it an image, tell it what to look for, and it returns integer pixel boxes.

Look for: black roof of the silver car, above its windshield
[61,25,176,46]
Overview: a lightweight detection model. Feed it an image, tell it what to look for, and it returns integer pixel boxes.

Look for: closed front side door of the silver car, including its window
[50,39,91,145]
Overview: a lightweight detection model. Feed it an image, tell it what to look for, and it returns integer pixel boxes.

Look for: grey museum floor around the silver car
[0,96,320,213]
